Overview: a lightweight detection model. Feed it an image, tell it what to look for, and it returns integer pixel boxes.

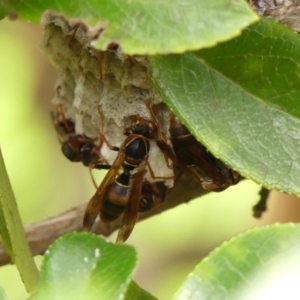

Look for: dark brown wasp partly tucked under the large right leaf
[146,101,240,192]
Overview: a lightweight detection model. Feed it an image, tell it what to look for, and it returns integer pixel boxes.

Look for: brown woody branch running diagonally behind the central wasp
[0,174,208,266]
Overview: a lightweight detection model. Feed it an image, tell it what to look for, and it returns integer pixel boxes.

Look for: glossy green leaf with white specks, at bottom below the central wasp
[37,233,137,300]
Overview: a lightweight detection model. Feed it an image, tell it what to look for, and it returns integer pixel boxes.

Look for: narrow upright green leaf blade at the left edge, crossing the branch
[0,150,39,293]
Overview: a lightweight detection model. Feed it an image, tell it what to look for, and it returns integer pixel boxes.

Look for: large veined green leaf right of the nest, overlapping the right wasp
[151,19,300,195]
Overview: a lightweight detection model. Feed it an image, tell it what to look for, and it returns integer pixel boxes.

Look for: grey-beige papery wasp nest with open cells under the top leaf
[41,12,173,186]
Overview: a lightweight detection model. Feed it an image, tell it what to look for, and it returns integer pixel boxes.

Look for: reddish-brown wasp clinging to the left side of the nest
[51,105,101,166]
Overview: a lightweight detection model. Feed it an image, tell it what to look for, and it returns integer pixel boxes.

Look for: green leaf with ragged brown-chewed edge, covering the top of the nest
[3,0,258,54]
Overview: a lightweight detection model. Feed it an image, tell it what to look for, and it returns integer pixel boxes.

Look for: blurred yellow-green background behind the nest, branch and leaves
[0,20,300,300]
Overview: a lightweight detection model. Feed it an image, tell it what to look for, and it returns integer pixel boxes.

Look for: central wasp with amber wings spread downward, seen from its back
[83,116,167,242]
